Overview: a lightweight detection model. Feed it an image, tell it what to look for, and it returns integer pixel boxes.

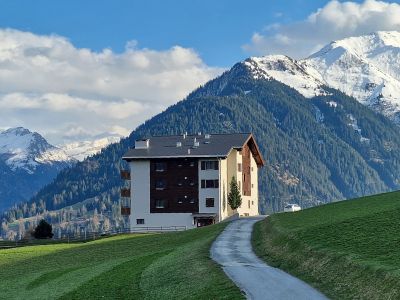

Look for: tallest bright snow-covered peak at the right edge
[308,31,400,123]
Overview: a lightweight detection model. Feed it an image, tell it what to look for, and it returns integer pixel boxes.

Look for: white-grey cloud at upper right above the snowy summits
[243,0,400,58]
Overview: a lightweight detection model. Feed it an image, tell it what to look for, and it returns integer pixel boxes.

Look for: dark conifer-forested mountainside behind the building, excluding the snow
[3,63,400,220]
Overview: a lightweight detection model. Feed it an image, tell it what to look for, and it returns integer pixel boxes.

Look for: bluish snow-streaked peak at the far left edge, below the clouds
[0,127,74,174]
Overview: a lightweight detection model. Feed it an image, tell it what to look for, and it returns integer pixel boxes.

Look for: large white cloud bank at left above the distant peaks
[0,29,222,143]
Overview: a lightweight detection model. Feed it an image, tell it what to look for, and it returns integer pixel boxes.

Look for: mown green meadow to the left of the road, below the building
[0,224,242,299]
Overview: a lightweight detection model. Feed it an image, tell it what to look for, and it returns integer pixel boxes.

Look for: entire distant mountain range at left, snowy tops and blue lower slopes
[0,127,119,211]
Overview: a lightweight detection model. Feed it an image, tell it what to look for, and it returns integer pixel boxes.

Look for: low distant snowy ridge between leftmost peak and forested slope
[59,136,121,161]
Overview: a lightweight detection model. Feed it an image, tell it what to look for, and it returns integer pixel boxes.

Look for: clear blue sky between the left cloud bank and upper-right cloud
[0,0,368,67]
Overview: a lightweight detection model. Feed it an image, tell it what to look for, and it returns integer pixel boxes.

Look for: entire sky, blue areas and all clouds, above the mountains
[0,0,400,144]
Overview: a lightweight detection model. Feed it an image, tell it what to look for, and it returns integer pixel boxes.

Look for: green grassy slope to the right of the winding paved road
[253,192,400,299]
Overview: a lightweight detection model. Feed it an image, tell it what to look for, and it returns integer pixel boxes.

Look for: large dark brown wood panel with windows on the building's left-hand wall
[150,158,199,213]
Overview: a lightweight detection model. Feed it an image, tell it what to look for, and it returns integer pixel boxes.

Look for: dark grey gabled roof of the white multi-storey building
[122,133,264,166]
